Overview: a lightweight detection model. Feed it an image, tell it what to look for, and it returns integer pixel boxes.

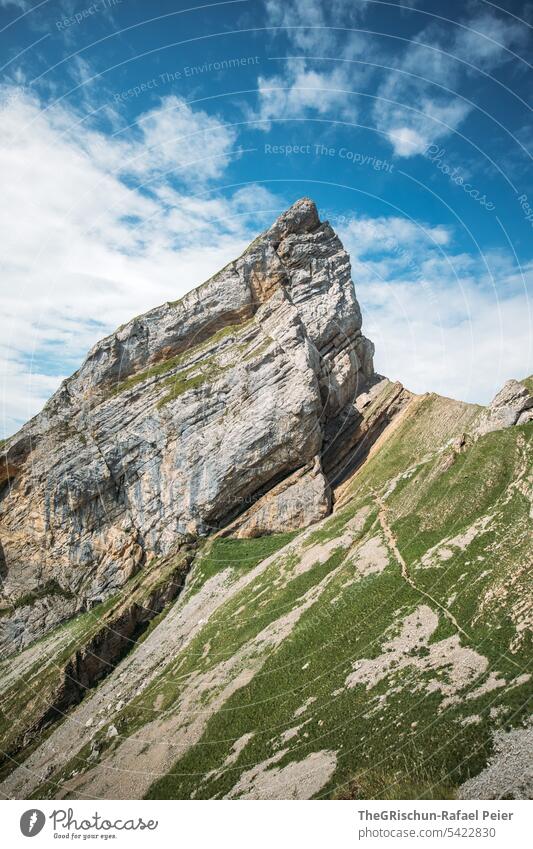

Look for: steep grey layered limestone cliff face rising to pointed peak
[0,199,373,651]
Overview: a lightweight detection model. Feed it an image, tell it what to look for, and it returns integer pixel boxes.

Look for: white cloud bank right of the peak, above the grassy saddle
[339,218,533,403]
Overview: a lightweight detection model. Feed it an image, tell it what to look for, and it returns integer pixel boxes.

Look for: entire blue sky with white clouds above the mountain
[0,0,533,437]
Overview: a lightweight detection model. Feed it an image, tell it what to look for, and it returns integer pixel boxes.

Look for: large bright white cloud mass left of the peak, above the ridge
[0,86,280,436]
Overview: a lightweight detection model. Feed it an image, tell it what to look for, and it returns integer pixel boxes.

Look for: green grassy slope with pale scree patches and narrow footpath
[28,395,533,799]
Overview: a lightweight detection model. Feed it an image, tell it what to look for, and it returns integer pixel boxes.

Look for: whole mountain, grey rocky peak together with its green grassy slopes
[0,199,533,798]
